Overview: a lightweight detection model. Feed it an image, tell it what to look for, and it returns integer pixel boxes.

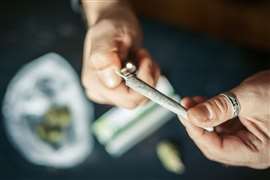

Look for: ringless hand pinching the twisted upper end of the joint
[82,5,159,108]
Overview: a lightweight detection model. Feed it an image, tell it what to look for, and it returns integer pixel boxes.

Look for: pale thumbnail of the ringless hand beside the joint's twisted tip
[98,68,121,88]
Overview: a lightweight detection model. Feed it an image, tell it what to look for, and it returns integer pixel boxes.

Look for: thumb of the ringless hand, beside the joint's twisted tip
[85,21,132,88]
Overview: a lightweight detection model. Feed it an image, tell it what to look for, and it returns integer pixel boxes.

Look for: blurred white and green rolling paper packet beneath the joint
[92,76,179,157]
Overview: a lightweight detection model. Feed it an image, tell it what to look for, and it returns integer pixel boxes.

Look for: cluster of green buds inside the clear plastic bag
[36,106,71,145]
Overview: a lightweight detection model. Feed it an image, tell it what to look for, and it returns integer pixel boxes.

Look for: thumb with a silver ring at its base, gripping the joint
[187,91,237,128]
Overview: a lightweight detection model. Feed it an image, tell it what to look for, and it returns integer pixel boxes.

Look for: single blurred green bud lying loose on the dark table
[156,141,185,174]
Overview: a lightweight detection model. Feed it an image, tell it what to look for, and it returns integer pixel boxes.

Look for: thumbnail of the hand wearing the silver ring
[188,105,211,122]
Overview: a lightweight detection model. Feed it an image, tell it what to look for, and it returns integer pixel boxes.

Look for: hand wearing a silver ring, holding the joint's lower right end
[181,70,270,169]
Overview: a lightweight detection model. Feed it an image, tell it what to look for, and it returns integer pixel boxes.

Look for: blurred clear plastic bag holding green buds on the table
[0,52,94,167]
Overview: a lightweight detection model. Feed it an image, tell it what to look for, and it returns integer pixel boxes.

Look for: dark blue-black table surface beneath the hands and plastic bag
[0,0,270,180]
